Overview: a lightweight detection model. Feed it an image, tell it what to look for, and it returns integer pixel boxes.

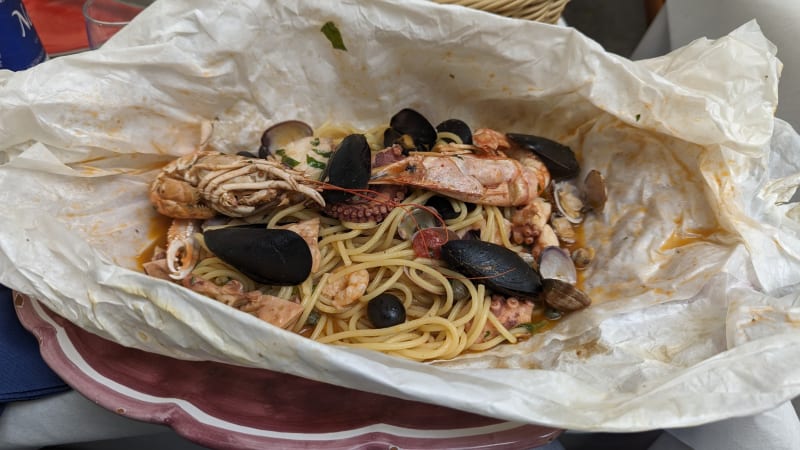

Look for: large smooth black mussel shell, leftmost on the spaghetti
[203,227,312,286]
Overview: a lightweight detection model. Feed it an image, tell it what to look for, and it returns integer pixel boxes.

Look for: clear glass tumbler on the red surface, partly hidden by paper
[83,0,142,50]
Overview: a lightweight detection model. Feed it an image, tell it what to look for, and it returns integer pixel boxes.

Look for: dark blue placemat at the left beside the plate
[0,285,69,413]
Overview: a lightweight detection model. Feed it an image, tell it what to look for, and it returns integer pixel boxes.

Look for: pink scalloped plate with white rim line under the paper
[14,293,561,449]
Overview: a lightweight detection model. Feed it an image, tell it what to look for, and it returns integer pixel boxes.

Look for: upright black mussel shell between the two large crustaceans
[322,134,372,204]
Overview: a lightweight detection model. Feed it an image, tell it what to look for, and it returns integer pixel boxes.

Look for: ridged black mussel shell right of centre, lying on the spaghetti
[442,239,542,298]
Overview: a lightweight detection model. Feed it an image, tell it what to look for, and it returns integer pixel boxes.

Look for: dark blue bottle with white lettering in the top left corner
[0,0,47,70]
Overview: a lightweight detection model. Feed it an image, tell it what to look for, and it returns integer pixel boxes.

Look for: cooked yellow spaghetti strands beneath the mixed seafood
[147,116,592,361]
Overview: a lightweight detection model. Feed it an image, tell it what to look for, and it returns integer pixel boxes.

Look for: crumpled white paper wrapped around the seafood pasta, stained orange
[0,0,800,431]
